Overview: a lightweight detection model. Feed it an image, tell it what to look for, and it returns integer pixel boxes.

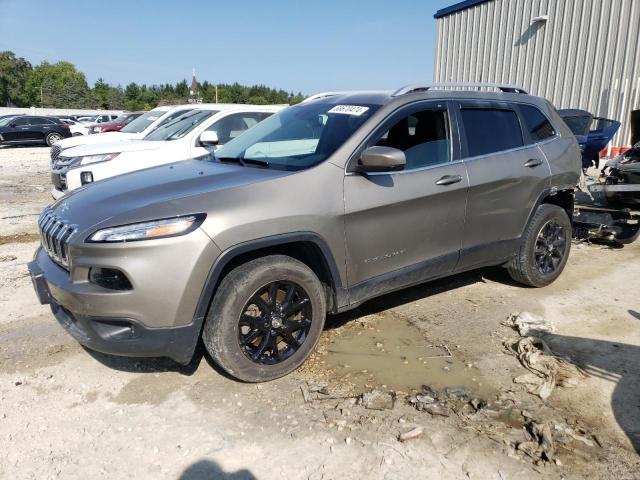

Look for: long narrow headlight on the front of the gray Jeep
[87,213,206,243]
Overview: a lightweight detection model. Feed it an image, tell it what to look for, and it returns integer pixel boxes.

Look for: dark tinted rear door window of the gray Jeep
[460,107,524,157]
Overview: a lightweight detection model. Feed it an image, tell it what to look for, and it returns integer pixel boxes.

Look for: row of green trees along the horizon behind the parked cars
[0,51,304,111]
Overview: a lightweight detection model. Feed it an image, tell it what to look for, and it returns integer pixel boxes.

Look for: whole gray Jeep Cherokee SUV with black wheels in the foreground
[29,85,581,382]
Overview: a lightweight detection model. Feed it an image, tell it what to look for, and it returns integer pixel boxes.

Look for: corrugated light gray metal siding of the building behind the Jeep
[434,0,640,145]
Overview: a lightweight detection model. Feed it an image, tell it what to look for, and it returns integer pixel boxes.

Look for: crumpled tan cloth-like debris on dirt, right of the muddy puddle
[507,337,589,400]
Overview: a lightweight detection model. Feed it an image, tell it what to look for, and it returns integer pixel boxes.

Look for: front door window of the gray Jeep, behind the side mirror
[376,109,451,170]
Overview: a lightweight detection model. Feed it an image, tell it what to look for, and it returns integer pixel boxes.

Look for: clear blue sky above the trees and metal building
[0,0,455,94]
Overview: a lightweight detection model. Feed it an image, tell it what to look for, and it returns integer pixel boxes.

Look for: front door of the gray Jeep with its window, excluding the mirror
[344,102,468,302]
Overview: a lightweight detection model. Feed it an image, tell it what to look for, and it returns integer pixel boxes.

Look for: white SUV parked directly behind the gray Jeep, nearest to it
[51,104,285,199]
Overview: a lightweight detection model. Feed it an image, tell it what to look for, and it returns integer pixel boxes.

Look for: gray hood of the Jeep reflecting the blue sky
[50,160,294,234]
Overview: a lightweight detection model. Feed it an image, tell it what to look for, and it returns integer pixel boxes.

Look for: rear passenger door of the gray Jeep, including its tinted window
[456,100,555,269]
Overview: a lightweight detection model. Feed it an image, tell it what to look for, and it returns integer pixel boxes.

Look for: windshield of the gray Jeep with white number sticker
[216,102,380,170]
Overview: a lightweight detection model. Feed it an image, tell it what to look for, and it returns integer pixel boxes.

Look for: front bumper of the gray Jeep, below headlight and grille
[28,230,219,364]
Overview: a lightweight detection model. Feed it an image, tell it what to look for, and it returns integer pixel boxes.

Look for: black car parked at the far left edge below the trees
[0,115,71,146]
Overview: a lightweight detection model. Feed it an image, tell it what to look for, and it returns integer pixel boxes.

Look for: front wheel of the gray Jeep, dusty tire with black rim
[202,255,326,382]
